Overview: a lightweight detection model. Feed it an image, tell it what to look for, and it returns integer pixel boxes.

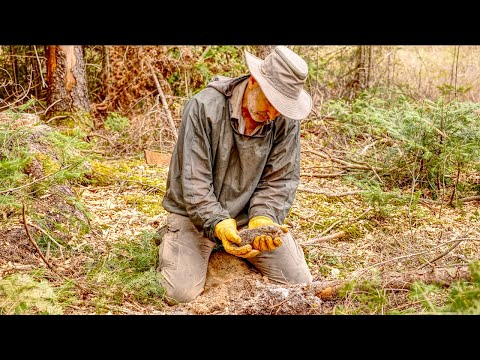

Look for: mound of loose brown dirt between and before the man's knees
[171,251,326,315]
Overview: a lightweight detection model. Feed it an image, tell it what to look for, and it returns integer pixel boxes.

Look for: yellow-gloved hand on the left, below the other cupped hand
[215,218,260,258]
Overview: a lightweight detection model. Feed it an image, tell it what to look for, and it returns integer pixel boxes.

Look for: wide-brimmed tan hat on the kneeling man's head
[245,46,312,120]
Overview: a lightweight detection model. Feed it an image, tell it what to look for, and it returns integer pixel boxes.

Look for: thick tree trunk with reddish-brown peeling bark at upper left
[47,45,90,116]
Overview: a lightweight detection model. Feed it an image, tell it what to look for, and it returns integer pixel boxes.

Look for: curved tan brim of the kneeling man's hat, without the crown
[245,51,312,120]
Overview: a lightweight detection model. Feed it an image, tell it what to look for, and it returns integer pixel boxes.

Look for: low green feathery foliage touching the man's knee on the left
[83,232,164,303]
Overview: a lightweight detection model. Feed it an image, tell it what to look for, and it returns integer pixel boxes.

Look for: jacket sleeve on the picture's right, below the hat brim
[248,119,300,224]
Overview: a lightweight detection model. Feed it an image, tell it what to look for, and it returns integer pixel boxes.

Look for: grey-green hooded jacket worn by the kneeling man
[162,75,300,241]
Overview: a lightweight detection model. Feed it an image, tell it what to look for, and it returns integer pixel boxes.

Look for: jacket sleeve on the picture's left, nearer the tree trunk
[179,99,230,241]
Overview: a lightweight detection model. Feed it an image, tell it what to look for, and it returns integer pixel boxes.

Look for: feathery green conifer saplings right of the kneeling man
[327,89,480,198]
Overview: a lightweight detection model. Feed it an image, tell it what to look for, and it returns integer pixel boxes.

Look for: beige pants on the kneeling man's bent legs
[157,213,312,304]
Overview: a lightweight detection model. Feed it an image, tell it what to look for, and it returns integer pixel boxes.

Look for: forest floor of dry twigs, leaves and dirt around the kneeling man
[0,130,480,315]
